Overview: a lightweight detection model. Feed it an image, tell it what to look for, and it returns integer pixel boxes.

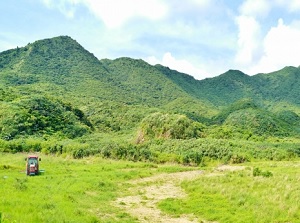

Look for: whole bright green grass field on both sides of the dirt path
[0,153,300,223]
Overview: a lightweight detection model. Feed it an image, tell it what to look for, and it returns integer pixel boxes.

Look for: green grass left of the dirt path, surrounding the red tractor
[0,153,192,223]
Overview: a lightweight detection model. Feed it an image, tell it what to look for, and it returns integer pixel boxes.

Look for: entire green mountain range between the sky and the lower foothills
[0,36,300,110]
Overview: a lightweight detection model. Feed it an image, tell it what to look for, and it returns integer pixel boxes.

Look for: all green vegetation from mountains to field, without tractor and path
[0,36,300,222]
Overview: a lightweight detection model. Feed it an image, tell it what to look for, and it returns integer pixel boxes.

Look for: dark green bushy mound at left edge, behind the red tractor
[0,96,91,140]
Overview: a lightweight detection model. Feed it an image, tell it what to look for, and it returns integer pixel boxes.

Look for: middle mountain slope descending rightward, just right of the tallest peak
[101,58,215,117]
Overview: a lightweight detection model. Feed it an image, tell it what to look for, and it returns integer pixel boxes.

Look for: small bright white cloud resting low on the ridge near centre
[145,52,211,79]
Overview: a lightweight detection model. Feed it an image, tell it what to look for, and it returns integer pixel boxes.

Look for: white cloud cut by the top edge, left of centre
[42,0,168,28]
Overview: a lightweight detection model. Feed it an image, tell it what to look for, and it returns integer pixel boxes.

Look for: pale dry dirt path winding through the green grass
[116,171,202,223]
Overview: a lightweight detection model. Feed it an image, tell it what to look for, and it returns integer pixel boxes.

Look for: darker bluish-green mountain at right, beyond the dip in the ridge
[198,67,300,109]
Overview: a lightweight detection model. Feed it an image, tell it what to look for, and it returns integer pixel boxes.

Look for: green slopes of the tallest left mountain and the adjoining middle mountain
[0,36,209,106]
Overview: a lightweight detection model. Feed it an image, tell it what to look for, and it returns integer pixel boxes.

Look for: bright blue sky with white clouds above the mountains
[0,0,300,79]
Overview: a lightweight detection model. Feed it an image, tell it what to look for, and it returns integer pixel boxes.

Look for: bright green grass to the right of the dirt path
[159,162,300,223]
